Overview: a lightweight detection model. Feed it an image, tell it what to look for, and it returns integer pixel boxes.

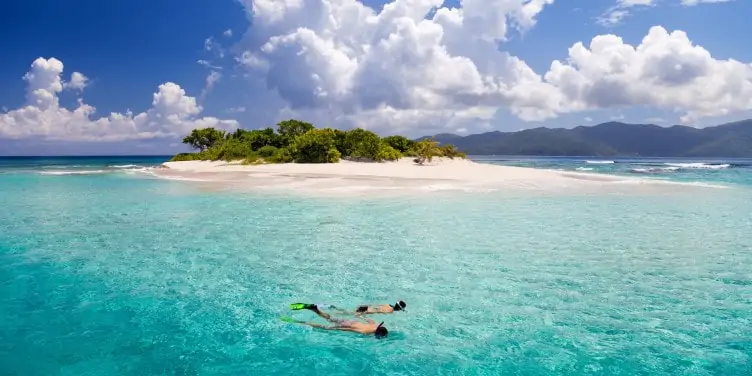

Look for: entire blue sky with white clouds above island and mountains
[0,0,752,155]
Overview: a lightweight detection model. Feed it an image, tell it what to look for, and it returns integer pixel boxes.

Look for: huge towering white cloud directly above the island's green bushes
[238,0,556,131]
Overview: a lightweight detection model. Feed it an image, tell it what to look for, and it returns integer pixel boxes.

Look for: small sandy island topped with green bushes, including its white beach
[156,119,720,197]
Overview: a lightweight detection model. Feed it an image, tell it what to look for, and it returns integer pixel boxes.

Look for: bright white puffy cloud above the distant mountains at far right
[545,26,752,122]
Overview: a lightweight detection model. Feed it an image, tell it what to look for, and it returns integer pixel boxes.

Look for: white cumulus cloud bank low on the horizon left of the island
[0,57,238,141]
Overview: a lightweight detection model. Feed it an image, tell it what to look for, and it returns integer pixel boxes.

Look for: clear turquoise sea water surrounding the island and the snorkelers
[0,157,752,375]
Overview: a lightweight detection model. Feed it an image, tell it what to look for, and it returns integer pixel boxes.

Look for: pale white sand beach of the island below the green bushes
[154,158,716,195]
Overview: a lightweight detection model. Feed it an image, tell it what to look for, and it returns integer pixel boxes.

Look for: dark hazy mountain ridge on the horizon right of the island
[418,119,752,158]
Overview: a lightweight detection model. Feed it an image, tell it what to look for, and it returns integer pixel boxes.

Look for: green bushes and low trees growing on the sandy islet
[171,119,466,165]
